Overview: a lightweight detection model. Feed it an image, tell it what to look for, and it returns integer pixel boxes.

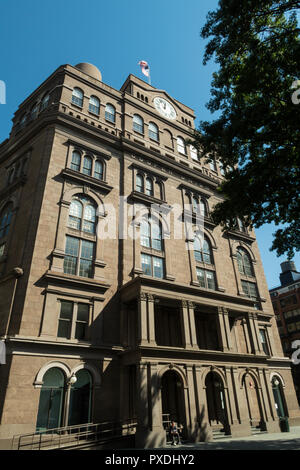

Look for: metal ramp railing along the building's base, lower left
[11,420,136,450]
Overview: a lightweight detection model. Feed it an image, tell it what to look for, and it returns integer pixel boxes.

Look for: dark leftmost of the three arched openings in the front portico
[161,370,186,429]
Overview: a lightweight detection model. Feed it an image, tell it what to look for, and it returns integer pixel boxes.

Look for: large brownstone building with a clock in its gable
[0,63,300,447]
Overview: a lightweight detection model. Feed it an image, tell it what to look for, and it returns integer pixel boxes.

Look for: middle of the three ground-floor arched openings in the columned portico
[205,372,228,431]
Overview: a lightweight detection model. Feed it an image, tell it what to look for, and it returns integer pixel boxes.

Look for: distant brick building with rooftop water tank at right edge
[270,261,300,404]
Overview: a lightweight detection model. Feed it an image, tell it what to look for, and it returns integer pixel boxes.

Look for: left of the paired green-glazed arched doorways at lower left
[36,367,65,431]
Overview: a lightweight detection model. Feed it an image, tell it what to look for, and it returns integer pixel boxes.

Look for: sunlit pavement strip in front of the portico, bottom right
[165,426,300,450]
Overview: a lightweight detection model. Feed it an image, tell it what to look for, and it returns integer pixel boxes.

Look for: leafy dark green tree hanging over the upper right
[193,0,300,258]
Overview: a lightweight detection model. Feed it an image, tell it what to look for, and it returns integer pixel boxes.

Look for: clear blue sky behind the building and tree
[0,0,300,287]
